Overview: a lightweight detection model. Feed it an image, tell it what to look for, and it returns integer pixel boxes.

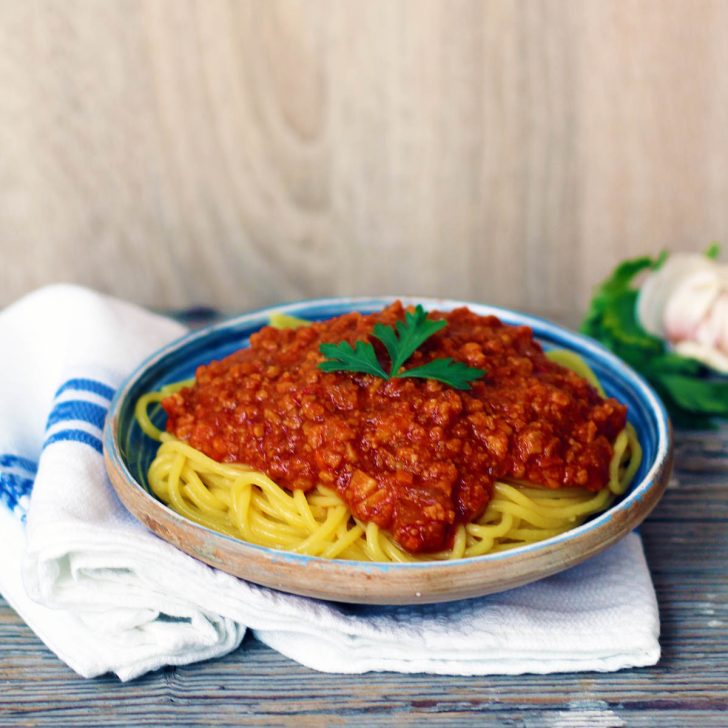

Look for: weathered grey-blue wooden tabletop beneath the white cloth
[0,426,728,728]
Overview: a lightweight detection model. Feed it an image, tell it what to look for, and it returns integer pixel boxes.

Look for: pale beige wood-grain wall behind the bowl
[0,0,728,322]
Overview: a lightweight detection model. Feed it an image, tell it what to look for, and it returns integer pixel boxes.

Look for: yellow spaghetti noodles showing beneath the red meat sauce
[135,350,642,562]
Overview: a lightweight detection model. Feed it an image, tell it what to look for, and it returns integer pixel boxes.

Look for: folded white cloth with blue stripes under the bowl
[0,286,660,680]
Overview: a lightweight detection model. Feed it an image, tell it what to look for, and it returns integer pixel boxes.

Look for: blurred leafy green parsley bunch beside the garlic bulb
[581,246,728,428]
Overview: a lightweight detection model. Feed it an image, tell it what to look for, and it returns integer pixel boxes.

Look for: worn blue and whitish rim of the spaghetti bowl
[103,295,672,573]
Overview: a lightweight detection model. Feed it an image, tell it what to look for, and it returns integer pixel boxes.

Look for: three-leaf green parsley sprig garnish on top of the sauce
[319,305,485,389]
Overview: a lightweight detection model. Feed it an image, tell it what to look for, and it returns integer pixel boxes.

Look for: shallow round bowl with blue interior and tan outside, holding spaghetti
[104,297,672,604]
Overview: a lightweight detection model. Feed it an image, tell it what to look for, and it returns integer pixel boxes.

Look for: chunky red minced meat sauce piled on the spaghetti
[163,303,626,553]
